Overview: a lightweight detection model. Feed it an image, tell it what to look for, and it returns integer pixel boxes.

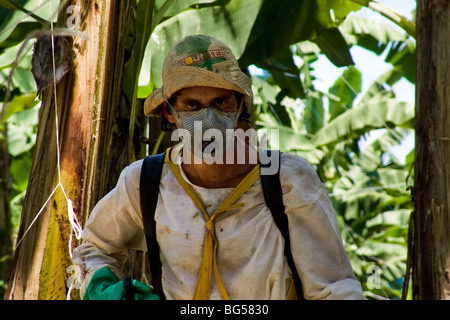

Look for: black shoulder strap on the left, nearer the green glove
[140,153,165,300]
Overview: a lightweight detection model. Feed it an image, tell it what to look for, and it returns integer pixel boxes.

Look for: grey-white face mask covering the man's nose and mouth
[168,101,243,155]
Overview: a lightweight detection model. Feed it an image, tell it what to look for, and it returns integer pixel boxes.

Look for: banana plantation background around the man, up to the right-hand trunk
[0,0,415,299]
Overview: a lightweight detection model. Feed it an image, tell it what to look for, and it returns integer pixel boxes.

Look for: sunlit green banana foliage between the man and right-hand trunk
[254,8,414,299]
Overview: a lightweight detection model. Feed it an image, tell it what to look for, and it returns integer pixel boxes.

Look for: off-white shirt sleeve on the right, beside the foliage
[280,154,364,300]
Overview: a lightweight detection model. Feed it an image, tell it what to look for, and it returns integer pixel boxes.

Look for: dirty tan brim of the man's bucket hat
[144,66,253,117]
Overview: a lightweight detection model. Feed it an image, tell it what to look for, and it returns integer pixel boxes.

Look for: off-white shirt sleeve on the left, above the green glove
[72,161,147,296]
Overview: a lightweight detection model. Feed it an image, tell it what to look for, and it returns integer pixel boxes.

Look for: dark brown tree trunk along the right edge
[413,0,450,300]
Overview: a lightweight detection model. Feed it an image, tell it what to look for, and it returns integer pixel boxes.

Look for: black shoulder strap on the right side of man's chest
[260,150,304,300]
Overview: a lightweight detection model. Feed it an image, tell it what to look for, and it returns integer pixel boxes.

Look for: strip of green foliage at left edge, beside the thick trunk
[0,1,43,297]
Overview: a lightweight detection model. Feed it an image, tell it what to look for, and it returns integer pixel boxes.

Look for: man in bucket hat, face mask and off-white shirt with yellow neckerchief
[73,35,363,299]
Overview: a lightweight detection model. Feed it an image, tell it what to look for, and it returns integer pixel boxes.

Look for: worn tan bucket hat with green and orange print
[144,35,253,116]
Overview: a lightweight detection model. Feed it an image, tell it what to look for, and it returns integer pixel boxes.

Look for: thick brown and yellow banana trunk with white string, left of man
[5,0,132,300]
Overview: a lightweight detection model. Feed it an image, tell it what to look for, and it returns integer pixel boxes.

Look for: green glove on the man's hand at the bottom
[83,267,159,300]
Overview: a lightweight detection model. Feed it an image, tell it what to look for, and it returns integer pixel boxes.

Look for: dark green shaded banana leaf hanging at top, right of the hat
[240,0,361,65]
